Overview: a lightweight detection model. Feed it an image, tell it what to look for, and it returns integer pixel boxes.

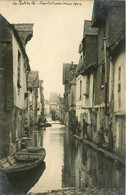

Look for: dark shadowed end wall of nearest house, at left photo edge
[0,17,13,158]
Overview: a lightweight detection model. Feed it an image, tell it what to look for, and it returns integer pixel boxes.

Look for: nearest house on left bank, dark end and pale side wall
[0,15,33,158]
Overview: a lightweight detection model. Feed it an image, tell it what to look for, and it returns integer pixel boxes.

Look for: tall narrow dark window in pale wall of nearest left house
[17,51,21,95]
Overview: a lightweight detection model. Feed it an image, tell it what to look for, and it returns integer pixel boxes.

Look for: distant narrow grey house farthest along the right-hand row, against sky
[63,62,77,126]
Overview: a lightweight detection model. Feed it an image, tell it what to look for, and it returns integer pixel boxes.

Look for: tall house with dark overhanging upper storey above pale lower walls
[76,20,98,138]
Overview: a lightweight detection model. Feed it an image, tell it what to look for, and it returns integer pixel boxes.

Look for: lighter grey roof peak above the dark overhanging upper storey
[83,20,98,37]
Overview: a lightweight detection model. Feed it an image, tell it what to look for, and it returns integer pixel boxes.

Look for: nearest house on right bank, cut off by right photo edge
[92,0,126,159]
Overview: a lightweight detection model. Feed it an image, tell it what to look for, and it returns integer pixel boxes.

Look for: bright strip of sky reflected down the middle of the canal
[30,124,66,193]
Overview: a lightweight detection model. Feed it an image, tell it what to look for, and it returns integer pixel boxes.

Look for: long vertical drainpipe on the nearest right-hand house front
[104,38,109,116]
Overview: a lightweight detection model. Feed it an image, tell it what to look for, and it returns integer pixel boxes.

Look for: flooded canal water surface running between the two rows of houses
[0,123,124,195]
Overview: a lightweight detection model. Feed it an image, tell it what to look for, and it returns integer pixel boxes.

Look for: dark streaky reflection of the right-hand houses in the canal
[62,132,125,195]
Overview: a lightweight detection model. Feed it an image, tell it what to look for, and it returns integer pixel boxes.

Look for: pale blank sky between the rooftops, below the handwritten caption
[0,0,93,99]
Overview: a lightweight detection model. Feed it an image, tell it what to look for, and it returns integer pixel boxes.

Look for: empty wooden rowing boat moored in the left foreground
[0,148,46,175]
